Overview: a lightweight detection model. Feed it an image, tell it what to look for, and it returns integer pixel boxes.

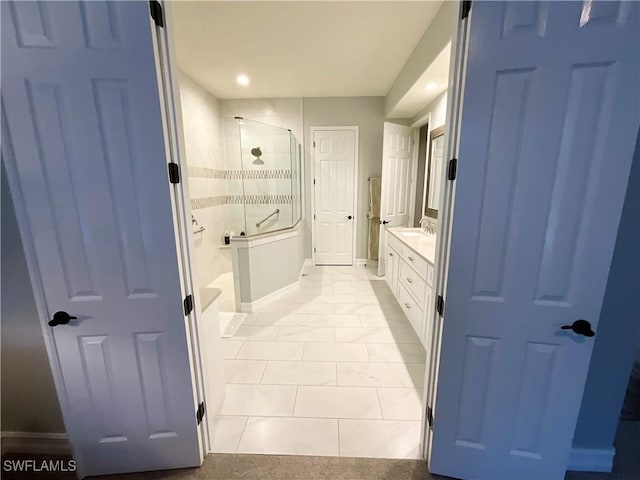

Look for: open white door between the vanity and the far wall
[378,122,412,276]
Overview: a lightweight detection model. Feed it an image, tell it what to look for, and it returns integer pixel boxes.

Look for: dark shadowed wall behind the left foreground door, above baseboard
[0,163,65,433]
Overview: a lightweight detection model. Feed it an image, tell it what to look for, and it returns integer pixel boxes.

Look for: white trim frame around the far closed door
[308,125,360,266]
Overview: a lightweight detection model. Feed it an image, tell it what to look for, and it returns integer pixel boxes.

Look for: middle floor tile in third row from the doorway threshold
[262,361,336,385]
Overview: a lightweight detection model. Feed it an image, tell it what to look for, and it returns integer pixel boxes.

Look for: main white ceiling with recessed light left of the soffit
[171,1,442,99]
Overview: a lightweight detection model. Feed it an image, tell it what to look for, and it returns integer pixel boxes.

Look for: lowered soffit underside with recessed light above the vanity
[389,42,451,118]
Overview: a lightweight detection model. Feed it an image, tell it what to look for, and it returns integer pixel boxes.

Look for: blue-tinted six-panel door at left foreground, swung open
[2,2,200,475]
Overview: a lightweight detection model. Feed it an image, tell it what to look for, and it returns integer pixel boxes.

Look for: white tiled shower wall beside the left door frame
[180,73,231,288]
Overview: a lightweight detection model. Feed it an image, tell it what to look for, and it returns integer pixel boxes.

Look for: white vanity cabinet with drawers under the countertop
[385,231,433,348]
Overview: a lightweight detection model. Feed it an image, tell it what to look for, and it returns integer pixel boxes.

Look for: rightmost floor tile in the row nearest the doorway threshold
[338,419,420,458]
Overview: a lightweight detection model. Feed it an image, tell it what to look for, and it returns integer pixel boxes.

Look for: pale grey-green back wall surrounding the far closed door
[304,97,385,259]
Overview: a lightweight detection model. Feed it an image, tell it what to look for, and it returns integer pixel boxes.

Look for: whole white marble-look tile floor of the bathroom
[213,266,425,458]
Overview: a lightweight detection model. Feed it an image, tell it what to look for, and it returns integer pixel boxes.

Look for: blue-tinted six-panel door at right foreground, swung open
[430,2,640,480]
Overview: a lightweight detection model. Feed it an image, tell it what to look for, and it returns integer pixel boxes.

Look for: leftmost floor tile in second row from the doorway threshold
[220,384,297,417]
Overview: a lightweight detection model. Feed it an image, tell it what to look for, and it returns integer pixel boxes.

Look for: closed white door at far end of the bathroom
[313,130,356,265]
